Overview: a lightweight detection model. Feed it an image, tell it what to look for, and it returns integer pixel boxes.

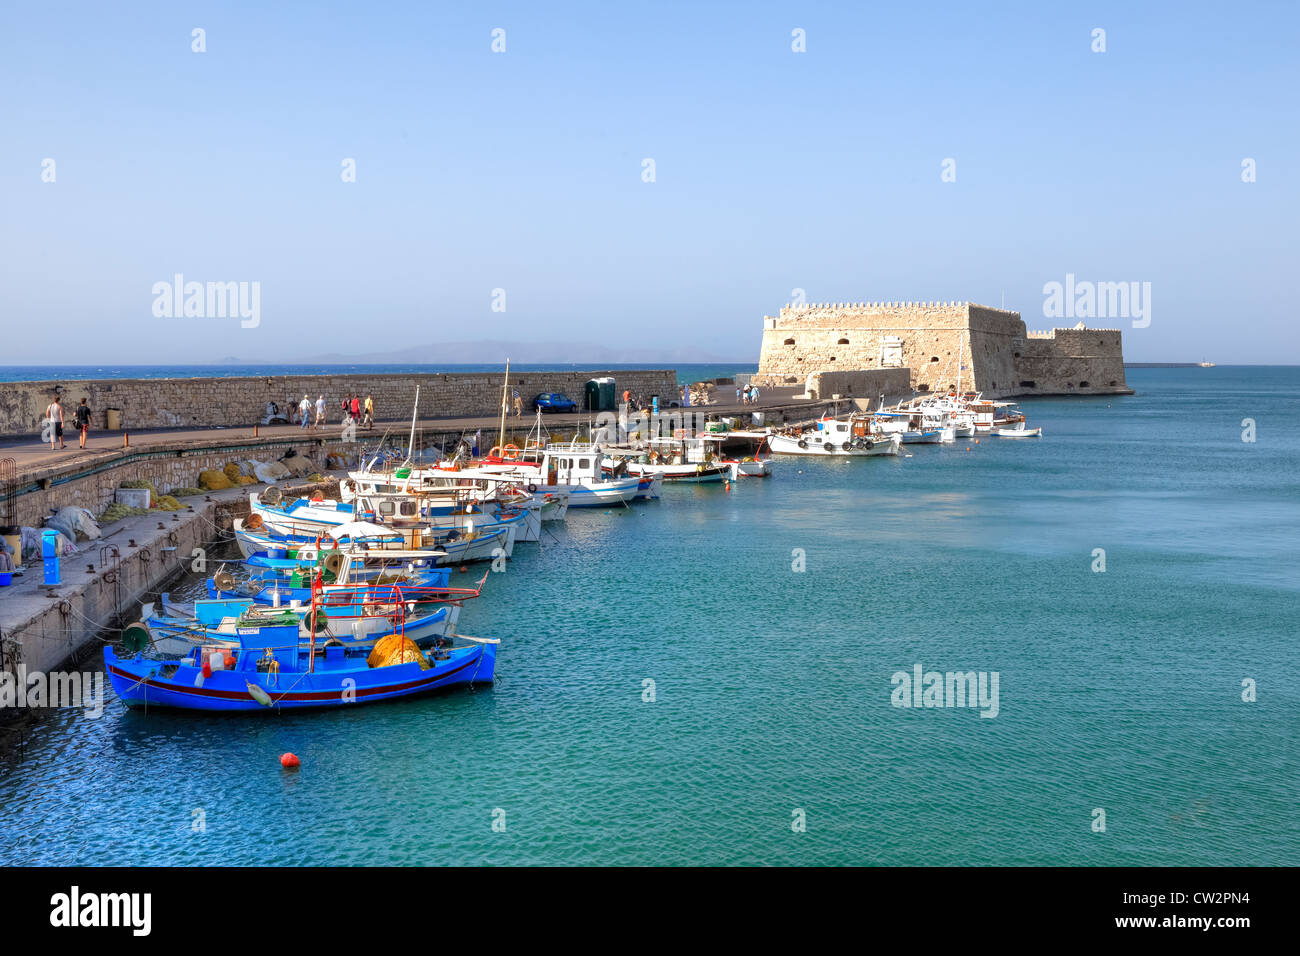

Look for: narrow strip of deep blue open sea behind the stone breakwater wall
[0,362,758,385]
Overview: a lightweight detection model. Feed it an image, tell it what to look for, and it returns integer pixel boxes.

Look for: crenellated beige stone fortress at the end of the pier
[753,302,1132,398]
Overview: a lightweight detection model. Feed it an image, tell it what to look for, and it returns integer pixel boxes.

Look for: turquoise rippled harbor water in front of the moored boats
[0,368,1300,865]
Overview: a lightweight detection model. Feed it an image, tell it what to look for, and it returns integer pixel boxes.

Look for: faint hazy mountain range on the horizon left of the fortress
[299,330,735,365]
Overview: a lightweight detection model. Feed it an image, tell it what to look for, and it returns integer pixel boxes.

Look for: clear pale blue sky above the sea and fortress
[0,1,1300,364]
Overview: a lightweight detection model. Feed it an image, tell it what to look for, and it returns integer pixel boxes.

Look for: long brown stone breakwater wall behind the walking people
[0,369,680,436]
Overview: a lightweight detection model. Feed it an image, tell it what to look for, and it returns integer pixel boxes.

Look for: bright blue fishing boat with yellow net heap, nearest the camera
[104,618,498,711]
